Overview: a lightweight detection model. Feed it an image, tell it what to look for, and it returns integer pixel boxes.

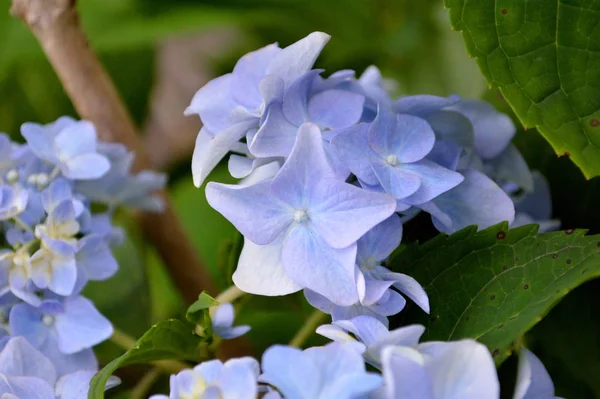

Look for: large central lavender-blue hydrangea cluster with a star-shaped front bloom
[186,32,557,325]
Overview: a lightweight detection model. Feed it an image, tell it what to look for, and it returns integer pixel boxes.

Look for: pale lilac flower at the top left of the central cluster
[185,32,330,187]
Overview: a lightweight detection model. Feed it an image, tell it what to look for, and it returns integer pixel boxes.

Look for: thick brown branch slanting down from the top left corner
[11,0,215,302]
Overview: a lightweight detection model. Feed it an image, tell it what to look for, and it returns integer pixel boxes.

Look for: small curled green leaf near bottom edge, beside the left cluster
[88,319,204,399]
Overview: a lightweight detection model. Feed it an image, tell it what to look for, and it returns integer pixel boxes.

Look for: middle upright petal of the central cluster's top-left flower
[231,44,281,110]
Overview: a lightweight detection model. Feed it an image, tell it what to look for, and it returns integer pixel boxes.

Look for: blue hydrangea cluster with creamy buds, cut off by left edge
[0,117,165,399]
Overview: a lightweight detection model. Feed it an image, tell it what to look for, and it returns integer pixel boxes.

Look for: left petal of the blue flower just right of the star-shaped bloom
[331,123,378,185]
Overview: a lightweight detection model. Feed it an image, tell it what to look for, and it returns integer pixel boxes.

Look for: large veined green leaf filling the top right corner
[445,0,600,178]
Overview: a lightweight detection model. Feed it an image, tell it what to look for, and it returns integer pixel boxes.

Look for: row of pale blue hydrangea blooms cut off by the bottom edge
[151,316,559,399]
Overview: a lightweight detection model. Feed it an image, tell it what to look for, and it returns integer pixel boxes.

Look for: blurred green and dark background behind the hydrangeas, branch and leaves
[0,0,600,398]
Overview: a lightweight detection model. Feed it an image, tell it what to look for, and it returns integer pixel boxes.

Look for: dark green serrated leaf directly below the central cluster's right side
[390,223,600,363]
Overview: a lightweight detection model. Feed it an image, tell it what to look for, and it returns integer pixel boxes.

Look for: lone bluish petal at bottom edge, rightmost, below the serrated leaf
[513,348,561,399]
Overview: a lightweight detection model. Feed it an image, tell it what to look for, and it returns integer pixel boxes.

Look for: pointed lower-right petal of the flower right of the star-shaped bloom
[400,159,464,205]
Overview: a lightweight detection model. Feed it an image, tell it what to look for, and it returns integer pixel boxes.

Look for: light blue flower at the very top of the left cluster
[21,117,110,180]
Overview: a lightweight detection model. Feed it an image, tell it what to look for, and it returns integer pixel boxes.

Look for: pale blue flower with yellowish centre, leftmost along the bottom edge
[150,357,259,399]
